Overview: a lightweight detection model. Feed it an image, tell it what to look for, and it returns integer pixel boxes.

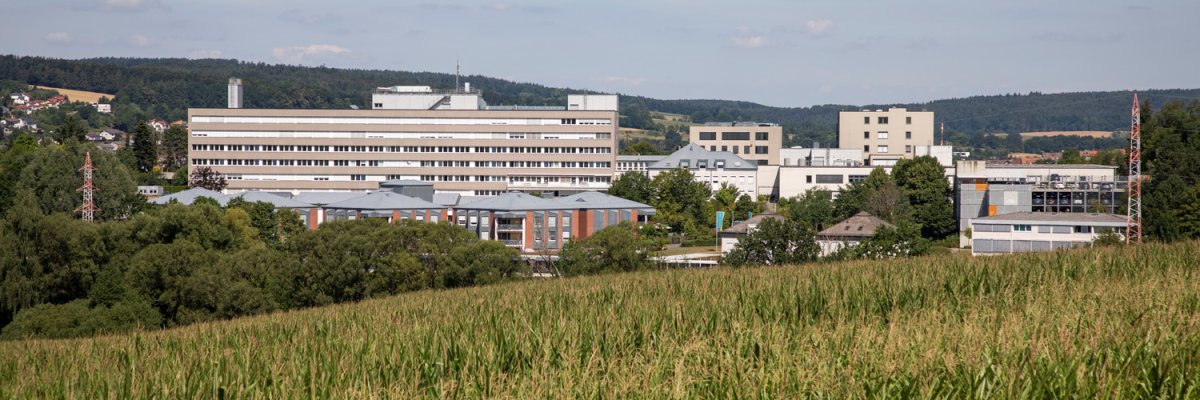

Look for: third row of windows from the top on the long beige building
[192,144,612,154]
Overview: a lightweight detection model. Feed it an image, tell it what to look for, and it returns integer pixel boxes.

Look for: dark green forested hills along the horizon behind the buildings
[7,55,1200,136]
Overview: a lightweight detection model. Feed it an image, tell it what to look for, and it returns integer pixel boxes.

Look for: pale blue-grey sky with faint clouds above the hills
[0,0,1200,107]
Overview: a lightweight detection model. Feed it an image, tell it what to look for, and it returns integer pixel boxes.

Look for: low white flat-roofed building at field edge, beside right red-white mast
[970,211,1128,255]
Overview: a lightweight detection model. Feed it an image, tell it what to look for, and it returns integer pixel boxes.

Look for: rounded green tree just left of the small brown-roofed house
[721,217,821,267]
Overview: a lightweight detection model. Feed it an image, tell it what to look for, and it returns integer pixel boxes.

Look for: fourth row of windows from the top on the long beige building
[192,159,612,168]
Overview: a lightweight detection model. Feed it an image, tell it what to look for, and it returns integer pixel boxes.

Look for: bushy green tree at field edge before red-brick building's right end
[558,222,661,275]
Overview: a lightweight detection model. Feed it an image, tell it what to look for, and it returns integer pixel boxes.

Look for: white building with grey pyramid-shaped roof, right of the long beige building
[647,143,758,198]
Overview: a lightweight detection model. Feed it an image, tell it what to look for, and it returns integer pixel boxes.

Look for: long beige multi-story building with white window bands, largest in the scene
[187,85,618,196]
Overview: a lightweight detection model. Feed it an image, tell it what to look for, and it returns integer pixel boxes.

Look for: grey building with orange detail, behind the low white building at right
[954,161,1128,246]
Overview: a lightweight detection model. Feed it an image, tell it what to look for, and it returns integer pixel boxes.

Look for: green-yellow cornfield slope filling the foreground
[0,243,1200,398]
